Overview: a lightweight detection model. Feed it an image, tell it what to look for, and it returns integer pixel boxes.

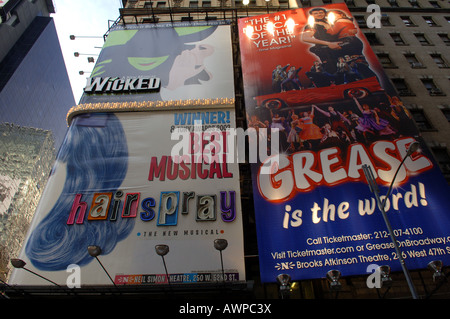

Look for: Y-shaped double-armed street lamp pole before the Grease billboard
[362,142,420,299]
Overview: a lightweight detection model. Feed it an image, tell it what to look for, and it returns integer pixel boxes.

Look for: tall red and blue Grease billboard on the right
[239,3,450,282]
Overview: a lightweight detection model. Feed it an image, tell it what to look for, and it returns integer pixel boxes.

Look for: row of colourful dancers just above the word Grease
[247,95,415,153]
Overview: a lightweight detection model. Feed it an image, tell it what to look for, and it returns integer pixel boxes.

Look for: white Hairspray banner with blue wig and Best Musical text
[11,109,245,285]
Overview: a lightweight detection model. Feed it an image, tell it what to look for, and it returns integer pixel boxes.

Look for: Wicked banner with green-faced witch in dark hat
[80,21,234,103]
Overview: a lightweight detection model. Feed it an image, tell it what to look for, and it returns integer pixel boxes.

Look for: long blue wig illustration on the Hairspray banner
[25,113,134,271]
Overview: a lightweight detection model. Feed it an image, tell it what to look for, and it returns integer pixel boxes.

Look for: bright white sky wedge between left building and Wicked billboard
[51,0,122,104]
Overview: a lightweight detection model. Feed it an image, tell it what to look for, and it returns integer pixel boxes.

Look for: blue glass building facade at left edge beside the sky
[0,16,75,149]
